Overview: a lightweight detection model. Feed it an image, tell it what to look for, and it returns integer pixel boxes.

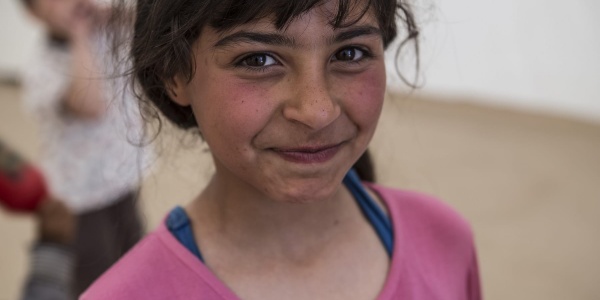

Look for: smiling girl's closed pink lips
[271,143,343,164]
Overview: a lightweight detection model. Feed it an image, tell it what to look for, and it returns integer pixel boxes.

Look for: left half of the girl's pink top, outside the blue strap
[80,222,231,300]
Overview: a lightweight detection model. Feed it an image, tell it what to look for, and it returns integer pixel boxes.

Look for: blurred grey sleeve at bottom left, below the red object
[22,243,74,300]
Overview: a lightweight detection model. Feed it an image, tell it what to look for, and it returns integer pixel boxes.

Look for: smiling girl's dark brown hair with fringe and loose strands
[116,0,418,181]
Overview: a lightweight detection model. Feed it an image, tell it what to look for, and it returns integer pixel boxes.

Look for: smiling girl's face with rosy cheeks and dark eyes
[172,1,386,202]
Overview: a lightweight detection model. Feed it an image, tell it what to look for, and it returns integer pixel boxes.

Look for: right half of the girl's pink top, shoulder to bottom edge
[368,184,481,299]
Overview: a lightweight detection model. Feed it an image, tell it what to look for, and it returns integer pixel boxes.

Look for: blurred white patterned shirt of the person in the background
[23,34,154,213]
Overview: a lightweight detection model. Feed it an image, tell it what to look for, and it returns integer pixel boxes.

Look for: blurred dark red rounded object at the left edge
[0,142,47,212]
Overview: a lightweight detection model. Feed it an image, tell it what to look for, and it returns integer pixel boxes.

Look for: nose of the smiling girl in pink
[283,70,341,130]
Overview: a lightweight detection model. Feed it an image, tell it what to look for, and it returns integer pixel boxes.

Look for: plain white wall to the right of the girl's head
[390,0,600,122]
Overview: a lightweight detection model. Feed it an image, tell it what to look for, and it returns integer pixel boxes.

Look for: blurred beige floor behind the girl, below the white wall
[0,87,600,300]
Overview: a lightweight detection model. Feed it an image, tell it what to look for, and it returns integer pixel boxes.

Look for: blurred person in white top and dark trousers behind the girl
[22,0,151,295]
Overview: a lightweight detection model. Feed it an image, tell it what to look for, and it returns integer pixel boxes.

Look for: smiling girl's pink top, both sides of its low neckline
[81,185,481,300]
